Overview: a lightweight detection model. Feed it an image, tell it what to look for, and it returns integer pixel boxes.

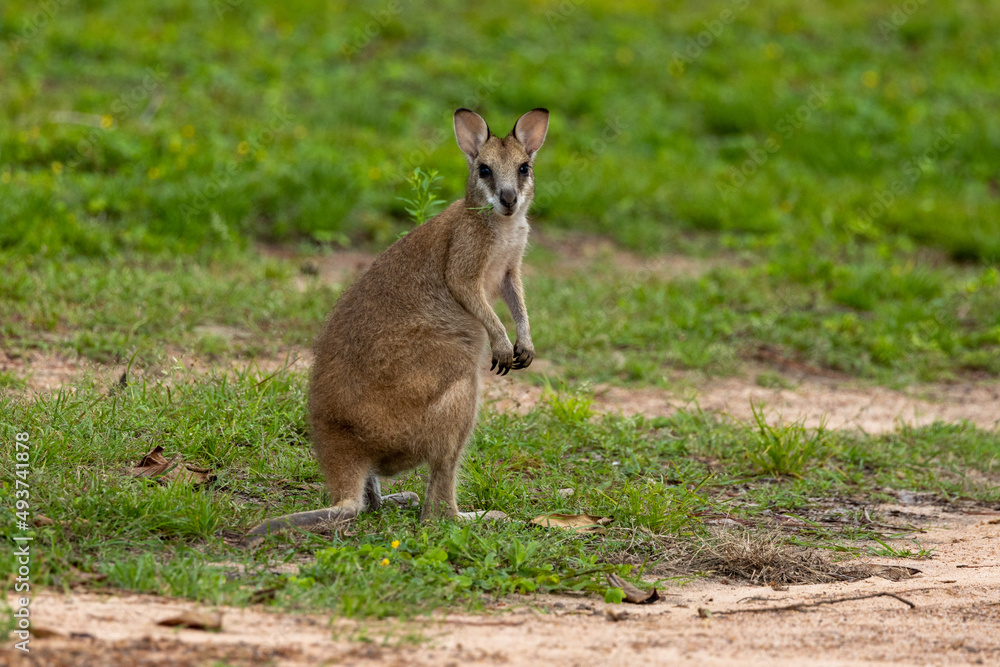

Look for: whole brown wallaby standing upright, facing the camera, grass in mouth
[245,109,549,543]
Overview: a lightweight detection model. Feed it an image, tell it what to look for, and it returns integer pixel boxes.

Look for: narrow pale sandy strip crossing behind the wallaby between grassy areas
[7,348,1000,434]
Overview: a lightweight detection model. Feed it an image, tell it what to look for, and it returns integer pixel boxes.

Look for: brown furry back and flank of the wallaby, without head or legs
[309,200,486,475]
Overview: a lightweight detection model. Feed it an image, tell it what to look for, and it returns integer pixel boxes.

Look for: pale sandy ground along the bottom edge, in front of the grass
[0,512,1000,666]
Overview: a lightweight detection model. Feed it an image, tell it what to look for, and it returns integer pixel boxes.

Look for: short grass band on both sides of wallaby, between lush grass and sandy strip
[0,219,1000,387]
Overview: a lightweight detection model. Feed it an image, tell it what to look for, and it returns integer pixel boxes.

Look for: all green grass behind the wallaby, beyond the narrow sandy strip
[0,0,1000,384]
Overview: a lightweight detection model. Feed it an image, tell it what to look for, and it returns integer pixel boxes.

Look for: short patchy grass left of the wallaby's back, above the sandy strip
[0,250,342,364]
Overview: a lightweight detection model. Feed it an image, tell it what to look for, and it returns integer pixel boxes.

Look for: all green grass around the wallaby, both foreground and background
[0,0,1000,616]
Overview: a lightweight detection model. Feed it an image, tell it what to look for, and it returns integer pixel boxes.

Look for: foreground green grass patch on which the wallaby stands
[0,370,1000,616]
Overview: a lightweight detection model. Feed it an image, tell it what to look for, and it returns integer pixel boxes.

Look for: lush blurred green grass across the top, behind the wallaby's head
[0,0,1000,262]
